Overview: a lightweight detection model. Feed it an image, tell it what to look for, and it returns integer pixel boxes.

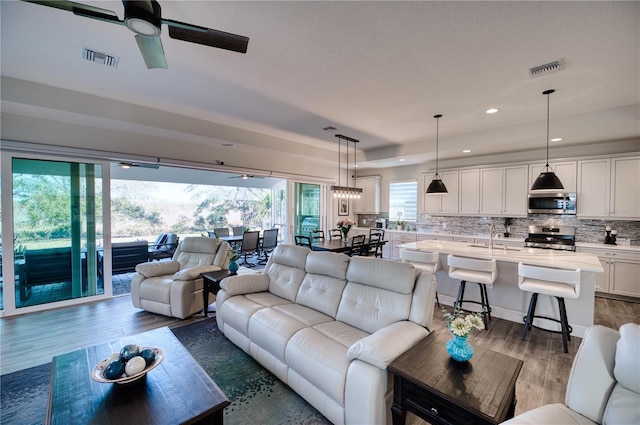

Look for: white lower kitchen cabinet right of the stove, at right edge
[578,247,640,298]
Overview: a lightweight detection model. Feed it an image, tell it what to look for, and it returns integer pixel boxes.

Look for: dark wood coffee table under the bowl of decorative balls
[46,327,230,425]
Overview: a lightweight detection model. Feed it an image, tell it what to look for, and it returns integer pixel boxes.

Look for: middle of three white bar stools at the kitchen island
[447,254,498,329]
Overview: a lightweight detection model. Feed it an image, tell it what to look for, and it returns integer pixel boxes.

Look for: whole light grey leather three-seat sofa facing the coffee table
[216,245,435,425]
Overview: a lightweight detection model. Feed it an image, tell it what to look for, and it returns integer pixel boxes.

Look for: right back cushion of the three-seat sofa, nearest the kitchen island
[336,257,416,333]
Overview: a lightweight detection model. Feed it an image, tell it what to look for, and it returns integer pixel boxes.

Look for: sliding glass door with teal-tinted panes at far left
[10,157,104,309]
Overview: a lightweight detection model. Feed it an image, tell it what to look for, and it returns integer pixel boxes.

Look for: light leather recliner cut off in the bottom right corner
[503,323,640,425]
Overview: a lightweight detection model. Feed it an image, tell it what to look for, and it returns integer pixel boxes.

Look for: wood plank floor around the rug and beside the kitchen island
[0,296,640,413]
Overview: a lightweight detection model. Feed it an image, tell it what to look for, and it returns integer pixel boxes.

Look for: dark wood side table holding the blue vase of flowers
[387,330,523,425]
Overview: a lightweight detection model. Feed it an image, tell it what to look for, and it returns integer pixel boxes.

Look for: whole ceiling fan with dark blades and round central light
[23,0,249,69]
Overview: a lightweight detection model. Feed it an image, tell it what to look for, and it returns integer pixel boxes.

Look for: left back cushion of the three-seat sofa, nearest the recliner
[263,245,311,302]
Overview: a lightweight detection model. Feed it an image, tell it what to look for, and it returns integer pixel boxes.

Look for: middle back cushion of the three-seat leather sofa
[296,252,349,319]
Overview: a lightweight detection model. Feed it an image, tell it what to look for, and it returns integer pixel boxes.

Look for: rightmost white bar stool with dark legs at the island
[518,263,581,353]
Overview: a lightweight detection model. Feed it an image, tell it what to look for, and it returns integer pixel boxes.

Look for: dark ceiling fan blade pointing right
[162,19,249,53]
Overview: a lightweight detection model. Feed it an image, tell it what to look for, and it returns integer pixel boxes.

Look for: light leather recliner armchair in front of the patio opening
[131,237,231,319]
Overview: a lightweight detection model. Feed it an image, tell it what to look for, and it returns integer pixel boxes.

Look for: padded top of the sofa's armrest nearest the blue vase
[347,321,429,369]
